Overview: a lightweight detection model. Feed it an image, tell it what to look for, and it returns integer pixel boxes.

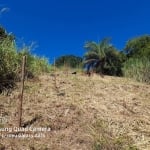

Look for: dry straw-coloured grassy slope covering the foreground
[0,72,150,150]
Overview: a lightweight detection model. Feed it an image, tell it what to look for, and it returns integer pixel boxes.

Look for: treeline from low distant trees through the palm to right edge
[56,35,150,83]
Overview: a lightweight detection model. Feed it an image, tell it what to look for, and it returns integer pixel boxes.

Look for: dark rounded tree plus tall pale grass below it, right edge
[122,35,150,83]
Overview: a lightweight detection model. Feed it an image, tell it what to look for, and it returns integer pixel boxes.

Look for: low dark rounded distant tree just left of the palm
[55,55,82,68]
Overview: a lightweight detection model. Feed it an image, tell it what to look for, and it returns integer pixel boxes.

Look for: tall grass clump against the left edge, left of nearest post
[0,37,18,93]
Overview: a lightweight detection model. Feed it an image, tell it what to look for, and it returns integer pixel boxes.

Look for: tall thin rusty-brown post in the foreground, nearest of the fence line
[18,56,26,127]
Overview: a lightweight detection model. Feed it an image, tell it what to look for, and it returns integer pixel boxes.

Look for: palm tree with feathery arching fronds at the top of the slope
[84,38,112,74]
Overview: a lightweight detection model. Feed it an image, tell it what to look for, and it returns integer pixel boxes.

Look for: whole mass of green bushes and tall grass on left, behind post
[0,27,50,93]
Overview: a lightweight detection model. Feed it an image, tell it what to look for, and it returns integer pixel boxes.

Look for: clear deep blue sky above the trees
[0,0,150,61]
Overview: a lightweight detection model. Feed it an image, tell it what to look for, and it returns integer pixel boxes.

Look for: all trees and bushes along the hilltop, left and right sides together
[0,27,150,93]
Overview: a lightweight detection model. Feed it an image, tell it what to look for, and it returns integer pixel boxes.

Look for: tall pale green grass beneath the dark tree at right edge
[122,57,150,84]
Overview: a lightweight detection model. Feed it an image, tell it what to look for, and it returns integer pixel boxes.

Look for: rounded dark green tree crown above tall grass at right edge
[124,35,150,58]
